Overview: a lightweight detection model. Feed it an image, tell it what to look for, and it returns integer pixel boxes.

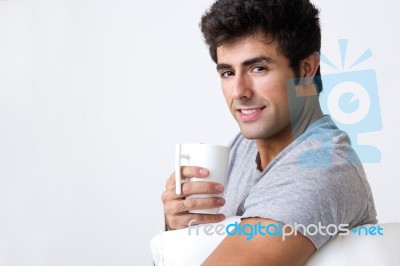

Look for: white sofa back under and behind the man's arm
[150,217,400,266]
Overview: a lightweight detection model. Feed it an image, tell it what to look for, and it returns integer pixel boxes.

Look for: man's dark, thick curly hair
[200,0,322,92]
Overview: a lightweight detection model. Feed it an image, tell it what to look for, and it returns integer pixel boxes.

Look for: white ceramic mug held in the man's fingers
[175,143,230,214]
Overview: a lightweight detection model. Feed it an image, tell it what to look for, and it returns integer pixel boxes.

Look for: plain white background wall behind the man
[0,0,400,266]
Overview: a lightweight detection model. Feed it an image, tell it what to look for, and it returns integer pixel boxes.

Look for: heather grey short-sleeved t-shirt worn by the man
[220,116,377,249]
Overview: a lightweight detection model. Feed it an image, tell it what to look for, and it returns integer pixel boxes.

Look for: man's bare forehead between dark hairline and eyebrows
[217,35,286,64]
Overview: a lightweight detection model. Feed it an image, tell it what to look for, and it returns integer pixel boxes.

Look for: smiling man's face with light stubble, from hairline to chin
[217,35,294,139]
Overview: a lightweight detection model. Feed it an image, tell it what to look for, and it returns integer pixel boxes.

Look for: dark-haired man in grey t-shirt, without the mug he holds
[162,0,377,265]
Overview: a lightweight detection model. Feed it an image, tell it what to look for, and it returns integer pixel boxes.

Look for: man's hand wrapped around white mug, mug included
[162,144,229,229]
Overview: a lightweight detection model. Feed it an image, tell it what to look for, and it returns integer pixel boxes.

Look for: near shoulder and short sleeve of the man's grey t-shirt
[245,119,376,248]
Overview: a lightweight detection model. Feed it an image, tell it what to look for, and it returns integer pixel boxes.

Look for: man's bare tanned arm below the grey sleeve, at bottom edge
[202,218,315,266]
